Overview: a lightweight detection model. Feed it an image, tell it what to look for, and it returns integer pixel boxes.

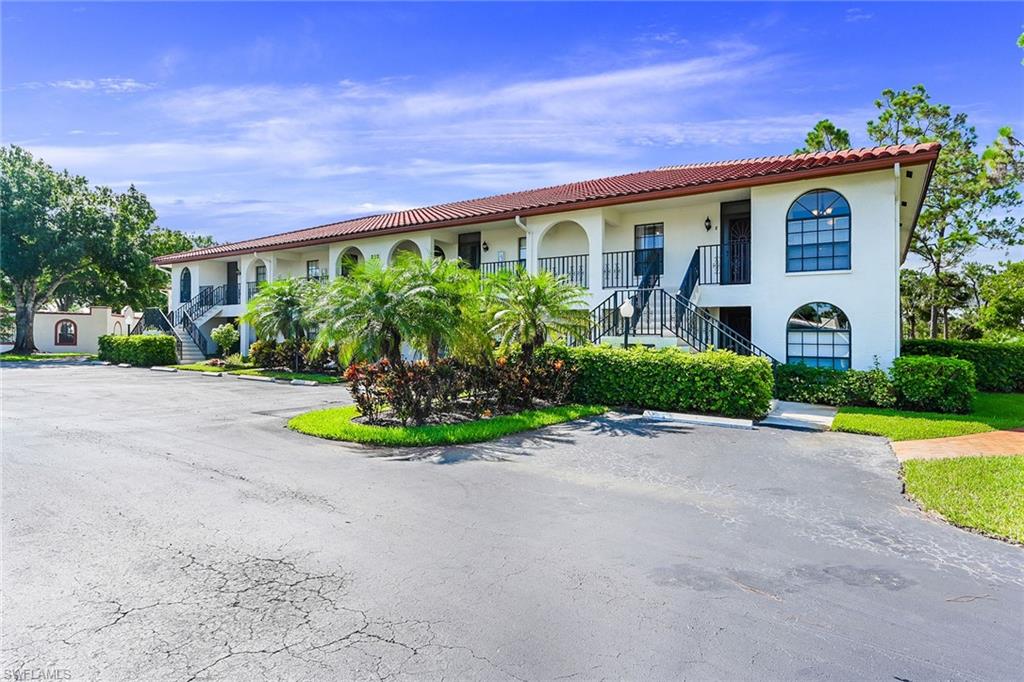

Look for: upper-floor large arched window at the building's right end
[785,189,850,272]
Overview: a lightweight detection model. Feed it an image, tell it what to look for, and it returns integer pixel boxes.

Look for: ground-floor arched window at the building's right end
[785,302,852,370]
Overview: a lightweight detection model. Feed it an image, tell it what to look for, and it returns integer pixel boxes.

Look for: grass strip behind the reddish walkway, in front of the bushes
[833,393,1024,440]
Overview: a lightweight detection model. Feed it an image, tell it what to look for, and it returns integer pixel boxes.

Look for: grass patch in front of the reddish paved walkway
[903,455,1024,544]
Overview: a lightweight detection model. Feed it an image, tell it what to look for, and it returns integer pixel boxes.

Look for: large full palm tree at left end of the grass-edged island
[311,251,441,364]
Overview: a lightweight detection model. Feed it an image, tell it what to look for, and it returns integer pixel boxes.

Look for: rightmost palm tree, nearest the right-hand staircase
[490,271,590,363]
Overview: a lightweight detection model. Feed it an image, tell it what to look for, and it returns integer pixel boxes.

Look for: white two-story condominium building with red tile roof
[154,144,939,369]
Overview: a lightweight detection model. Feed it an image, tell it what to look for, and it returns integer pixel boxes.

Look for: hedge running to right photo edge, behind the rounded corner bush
[902,339,1024,393]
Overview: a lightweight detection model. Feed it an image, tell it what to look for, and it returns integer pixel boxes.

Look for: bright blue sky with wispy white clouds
[2,2,1024,254]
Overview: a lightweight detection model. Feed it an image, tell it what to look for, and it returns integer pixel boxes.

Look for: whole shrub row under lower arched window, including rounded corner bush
[775,355,975,413]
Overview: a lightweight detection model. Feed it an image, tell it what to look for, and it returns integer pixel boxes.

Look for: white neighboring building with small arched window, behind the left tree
[0,305,141,353]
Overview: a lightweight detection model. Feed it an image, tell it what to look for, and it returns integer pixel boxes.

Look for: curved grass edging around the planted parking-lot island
[288,404,607,445]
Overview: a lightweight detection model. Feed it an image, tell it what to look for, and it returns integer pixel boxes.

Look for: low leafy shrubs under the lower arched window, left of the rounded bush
[775,365,896,408]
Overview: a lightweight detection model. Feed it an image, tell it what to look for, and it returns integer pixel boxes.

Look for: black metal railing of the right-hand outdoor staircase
[590,289,778,366]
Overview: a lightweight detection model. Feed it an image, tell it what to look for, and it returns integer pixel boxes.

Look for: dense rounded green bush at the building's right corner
[892,355,975,414]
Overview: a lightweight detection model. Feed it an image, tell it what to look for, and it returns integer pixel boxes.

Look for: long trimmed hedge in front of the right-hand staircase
[540,345,773,419]
